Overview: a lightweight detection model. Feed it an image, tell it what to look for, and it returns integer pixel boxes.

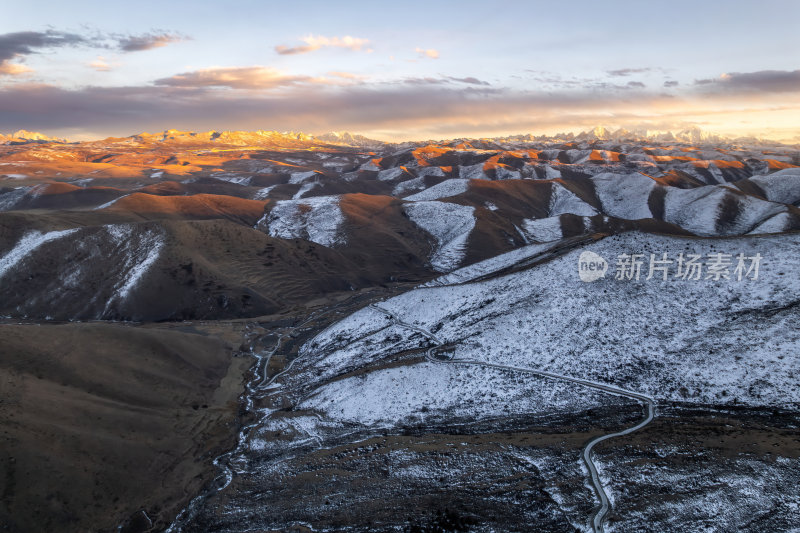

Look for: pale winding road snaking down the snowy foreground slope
[370,304,655,533]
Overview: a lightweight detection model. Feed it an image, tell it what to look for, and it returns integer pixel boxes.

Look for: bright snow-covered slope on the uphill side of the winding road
[334,233,800,406]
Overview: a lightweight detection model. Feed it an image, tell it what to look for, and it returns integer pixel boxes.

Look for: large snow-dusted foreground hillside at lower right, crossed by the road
[177,232,800,532]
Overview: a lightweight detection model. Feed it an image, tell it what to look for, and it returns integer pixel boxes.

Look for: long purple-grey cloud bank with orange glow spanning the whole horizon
[0,67,800,139]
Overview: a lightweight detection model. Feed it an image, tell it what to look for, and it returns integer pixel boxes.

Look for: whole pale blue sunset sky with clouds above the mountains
[0,0,800,142]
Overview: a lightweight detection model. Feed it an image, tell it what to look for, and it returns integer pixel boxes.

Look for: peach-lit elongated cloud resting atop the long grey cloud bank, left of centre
[154,66,316,89]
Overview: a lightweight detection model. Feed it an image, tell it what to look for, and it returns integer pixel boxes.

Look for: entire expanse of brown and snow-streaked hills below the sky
[0,123,800,533]
